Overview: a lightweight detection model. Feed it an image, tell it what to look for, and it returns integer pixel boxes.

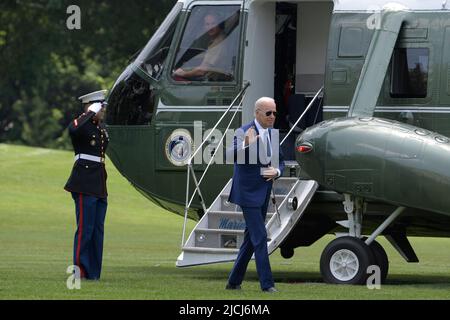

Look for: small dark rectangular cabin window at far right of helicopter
[390,48,429,98]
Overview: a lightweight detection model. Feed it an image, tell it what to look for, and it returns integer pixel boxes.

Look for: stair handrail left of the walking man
[181,81,250,248]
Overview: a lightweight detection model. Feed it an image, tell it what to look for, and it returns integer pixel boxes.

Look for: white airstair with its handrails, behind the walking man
[176,82,323,267]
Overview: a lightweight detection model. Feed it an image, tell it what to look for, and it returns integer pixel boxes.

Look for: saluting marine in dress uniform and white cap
[64,90,109,280]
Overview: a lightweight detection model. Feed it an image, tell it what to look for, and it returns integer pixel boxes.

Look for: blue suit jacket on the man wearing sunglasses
[228,121,284,207]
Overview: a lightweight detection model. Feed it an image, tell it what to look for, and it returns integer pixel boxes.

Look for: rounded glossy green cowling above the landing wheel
[296,117,450,215]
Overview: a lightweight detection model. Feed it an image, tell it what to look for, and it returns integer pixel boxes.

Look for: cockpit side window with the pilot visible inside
[172,5,240,82]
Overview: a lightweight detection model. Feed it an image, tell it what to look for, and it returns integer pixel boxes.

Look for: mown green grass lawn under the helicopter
[0,144,450,300]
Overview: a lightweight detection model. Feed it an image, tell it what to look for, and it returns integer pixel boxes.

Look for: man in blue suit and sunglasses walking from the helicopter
[226,97,284,292]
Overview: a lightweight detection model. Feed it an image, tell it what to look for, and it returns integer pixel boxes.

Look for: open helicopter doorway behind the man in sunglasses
[274,1,333,160]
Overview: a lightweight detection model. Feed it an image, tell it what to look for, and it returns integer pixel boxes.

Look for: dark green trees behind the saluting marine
[0,0,176,149]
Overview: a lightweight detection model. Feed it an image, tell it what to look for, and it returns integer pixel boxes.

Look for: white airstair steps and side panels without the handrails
[176,177,318,267]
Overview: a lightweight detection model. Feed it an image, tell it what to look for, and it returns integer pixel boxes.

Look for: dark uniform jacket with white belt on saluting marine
[64,111,109,198]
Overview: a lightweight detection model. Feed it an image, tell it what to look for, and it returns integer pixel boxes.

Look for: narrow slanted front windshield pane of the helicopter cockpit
[136,2,183,80]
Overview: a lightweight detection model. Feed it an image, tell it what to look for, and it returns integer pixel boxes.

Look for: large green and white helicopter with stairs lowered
[106,0,450,284]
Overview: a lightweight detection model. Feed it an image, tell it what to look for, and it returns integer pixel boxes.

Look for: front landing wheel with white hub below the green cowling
[320,236,375,284]
